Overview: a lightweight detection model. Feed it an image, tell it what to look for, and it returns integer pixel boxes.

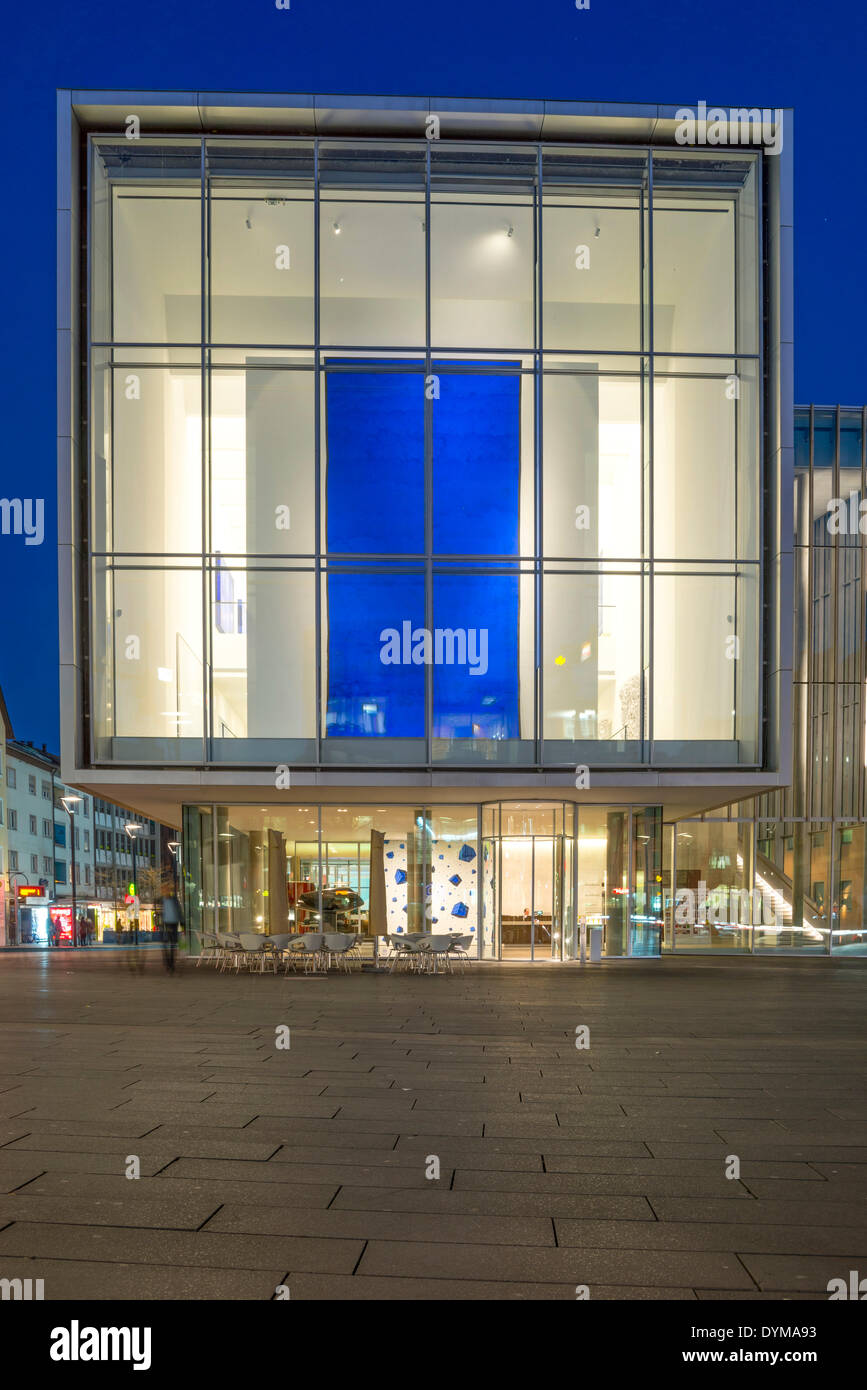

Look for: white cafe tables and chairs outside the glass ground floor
[196,931,472,974]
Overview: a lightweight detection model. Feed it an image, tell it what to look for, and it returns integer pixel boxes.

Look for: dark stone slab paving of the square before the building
[0,951,867,1300]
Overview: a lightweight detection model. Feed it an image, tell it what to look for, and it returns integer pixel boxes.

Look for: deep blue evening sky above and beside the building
[0,0,867,748]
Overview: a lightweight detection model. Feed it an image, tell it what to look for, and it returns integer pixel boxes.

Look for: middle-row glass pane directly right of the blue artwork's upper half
[542,368,642,560]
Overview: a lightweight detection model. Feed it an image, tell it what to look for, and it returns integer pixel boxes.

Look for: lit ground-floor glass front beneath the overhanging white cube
[183,802,663,962]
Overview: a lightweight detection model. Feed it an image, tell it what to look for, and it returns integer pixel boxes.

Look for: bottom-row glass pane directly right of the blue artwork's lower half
[542,573,642,762]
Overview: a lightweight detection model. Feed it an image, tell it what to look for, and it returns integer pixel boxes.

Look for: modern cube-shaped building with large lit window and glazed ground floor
[58,92,793,960]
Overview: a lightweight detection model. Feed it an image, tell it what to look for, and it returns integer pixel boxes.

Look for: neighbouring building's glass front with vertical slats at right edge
[666,406,867,955]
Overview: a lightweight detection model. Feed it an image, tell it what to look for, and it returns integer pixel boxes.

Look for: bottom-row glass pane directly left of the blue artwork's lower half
[211,560,317,762]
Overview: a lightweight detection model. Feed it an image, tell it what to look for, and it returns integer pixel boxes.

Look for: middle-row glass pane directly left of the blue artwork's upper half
[210,359,315,556]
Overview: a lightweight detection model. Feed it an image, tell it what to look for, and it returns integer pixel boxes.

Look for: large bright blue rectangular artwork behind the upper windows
[325,359,521,739]
